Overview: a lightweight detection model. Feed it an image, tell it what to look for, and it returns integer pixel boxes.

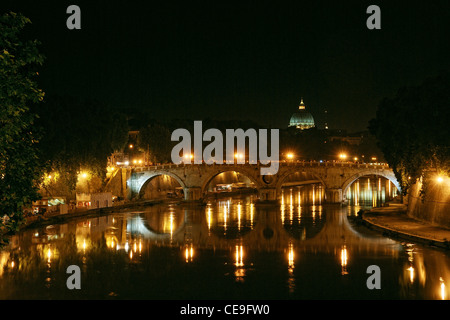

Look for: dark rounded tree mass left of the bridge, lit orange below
[37,96,128,190]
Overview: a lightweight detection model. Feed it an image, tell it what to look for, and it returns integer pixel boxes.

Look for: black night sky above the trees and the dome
[0,0,450,131]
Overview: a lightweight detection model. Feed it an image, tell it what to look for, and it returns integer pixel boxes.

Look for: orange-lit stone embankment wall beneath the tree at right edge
[407,175,450,228]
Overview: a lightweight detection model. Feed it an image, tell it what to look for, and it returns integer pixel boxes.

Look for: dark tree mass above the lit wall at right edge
[369,73,450,194]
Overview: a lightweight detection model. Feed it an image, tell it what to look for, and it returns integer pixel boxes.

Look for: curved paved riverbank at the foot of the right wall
[361,203,450,250]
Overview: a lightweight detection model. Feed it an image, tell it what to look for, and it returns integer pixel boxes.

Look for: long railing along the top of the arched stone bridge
[129,160,389,172]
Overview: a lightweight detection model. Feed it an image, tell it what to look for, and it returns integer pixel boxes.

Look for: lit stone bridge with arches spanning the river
[111,161,400,203]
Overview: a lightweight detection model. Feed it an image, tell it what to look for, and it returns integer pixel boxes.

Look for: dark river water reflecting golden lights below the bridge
[0,182,450,300]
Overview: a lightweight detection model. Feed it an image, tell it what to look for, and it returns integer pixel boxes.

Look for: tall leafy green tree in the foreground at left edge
[0,12,44,238]
